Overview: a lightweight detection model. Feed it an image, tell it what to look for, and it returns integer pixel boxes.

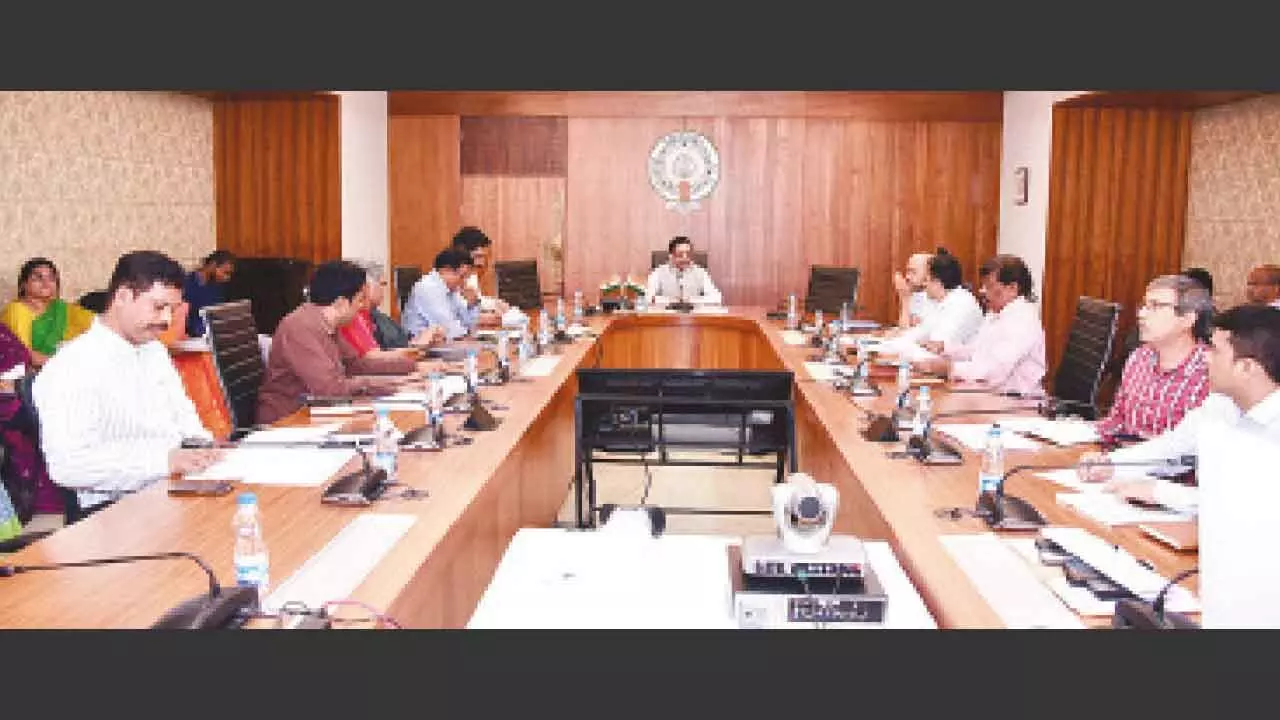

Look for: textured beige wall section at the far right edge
[1183,94,1280,307]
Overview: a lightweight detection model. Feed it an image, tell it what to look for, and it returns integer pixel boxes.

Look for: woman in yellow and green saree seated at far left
[0,258,93,369]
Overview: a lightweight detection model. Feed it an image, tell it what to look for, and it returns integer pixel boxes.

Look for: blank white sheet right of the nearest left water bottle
[262,512,417,612]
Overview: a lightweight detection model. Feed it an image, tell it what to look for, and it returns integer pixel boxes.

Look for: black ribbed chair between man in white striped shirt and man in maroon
[200,300,266,437]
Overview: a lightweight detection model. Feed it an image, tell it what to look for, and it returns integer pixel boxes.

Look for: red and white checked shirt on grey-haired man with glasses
[1097,343,1208,442]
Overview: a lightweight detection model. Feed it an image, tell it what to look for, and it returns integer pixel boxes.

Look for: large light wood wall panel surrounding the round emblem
[564,118,1000,313]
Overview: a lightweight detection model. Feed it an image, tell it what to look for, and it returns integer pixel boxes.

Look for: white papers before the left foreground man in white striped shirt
[187,443,356,487]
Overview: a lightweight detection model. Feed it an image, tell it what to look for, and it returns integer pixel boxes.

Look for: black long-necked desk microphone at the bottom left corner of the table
[0,552,259,630]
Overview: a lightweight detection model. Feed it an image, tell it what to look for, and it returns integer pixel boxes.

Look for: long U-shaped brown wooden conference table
[0,307,1197,628]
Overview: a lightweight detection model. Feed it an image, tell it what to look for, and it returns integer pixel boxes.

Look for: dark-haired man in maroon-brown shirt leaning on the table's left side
[257,260,417,424]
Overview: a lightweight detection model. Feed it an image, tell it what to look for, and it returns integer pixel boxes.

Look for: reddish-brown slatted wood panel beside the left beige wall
[214,95,342,261]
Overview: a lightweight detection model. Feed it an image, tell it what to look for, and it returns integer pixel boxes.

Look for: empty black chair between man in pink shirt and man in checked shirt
[1053,296,1120,420]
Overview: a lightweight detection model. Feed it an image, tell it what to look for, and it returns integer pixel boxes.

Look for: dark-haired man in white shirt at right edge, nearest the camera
[1080,305,1280,512]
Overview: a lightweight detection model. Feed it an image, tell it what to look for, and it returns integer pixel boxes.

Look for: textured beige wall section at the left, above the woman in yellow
[0,91,215,301]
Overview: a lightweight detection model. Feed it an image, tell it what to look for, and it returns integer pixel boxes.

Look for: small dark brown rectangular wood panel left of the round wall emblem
[461,117,568,177]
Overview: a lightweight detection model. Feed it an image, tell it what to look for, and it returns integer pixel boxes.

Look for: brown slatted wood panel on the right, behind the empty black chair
[1042,106,1192,378]
